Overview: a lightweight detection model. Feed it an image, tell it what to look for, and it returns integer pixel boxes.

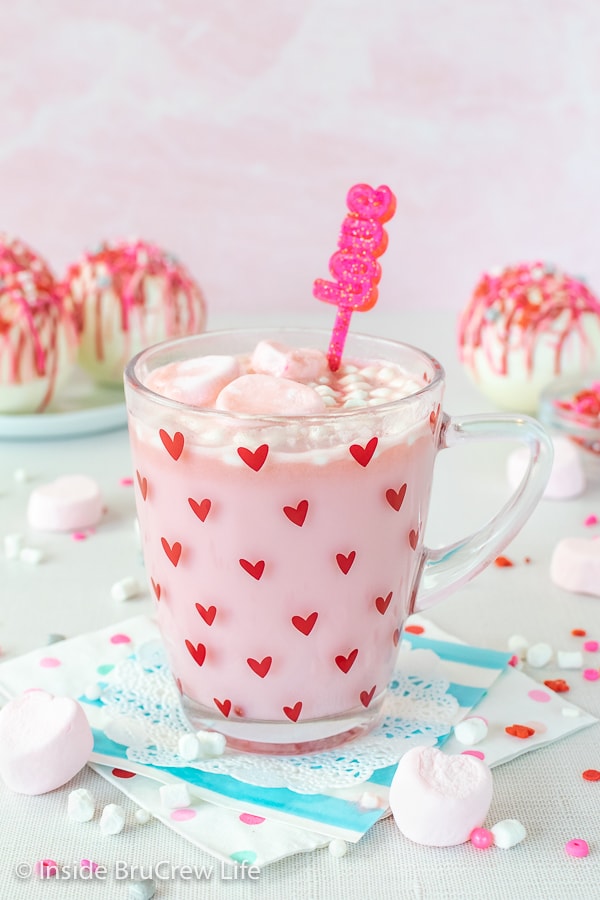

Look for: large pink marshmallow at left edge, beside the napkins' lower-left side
[0,690,94,794]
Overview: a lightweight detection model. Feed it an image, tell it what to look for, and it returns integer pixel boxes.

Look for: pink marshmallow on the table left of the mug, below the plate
[27,475,103,531]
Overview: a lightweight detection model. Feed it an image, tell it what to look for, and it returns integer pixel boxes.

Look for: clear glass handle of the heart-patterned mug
[410,415,554,613]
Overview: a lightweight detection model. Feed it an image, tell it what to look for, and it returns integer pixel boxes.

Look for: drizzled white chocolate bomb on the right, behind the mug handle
[458,262,600,412]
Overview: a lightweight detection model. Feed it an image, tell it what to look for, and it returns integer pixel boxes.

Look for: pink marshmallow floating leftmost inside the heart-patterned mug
[146,355,240,406]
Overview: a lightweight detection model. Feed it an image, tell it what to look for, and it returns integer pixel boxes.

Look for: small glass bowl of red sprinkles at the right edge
[539,372,600,466]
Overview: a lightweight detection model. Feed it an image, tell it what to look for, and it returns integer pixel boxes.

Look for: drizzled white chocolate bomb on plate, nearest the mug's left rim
[64,240,206,384]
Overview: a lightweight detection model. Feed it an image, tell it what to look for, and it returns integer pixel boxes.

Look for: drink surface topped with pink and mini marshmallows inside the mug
[146,341,426,416]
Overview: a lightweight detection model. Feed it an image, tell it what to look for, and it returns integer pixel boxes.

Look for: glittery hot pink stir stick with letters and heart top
[313,184,396,372]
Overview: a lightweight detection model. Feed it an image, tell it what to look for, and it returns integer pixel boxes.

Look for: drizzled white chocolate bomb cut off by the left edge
[0,234,77,413]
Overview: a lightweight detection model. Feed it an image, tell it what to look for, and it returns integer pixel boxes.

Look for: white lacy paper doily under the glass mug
[101,642,459,794]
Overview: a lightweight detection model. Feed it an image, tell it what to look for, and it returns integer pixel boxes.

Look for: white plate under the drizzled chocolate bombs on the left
[0,371,127,440]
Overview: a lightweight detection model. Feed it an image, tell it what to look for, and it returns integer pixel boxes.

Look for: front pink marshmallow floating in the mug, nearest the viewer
[215,375,327,416]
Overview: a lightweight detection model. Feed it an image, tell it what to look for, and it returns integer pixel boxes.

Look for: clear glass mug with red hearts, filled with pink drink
[125,329,552,753]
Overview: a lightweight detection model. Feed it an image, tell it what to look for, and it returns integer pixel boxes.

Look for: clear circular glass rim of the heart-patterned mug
[123,325,446,424]
